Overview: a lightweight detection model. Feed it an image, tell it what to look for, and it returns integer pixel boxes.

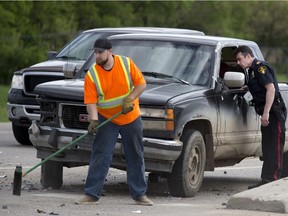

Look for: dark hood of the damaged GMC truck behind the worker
[34,79,204,105]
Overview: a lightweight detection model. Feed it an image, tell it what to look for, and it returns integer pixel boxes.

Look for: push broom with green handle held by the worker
[13,112,122,196]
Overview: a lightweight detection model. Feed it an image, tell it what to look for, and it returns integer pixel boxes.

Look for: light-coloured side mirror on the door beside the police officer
[224,71,245,88]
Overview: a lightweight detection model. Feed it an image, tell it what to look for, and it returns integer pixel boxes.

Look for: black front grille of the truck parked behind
[24,72,64,95]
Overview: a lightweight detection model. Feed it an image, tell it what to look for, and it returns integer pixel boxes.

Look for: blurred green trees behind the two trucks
[0,0,288,83]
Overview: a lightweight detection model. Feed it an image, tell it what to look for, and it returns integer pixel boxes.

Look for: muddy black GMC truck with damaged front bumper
[29,34,288,197]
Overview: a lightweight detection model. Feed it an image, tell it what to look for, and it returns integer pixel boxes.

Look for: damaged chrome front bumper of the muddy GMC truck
[28,121,183,173]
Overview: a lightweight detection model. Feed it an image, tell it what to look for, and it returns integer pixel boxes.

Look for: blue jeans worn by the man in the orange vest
[85,114,147,199]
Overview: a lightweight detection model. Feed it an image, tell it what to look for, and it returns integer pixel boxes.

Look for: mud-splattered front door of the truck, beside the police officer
[215,47,260,158]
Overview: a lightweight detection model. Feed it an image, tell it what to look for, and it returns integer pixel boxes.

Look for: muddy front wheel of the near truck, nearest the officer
[168,129,206,197]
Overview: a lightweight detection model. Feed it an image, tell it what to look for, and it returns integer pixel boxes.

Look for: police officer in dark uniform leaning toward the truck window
[234,46,287,189]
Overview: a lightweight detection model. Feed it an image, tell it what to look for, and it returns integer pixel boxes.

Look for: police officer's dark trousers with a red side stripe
[261,112,285,181]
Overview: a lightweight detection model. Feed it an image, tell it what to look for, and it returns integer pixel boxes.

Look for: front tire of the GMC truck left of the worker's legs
[40,161,63,189]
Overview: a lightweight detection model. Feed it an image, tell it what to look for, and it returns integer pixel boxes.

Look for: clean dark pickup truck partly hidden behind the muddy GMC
[7,27,204,145]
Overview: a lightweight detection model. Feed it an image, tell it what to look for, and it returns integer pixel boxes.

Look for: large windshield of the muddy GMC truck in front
[78,40,214,85]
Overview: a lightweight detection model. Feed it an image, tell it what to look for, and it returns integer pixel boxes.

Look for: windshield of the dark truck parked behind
[56,32,115,60]
